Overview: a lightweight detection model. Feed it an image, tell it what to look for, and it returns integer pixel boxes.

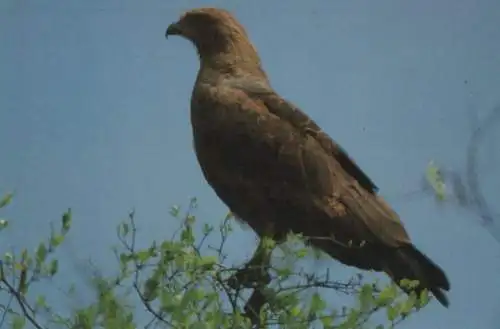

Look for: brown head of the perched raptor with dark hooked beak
[166,8,260,68]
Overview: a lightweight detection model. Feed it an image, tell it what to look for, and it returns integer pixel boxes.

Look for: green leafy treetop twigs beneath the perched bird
[0,196,429,329]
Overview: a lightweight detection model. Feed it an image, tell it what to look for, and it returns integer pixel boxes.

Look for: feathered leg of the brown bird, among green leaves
[228,238,274,289]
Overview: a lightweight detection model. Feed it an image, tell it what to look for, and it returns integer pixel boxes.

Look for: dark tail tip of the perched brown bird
[384,245,450,307]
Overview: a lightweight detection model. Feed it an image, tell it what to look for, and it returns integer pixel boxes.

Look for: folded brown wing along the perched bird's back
[217,81,410,246]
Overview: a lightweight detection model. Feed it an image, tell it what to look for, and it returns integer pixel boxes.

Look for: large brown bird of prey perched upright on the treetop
[167,8,450,306]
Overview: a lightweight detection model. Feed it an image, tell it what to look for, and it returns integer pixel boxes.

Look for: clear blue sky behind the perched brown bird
[0,0,500,329]
